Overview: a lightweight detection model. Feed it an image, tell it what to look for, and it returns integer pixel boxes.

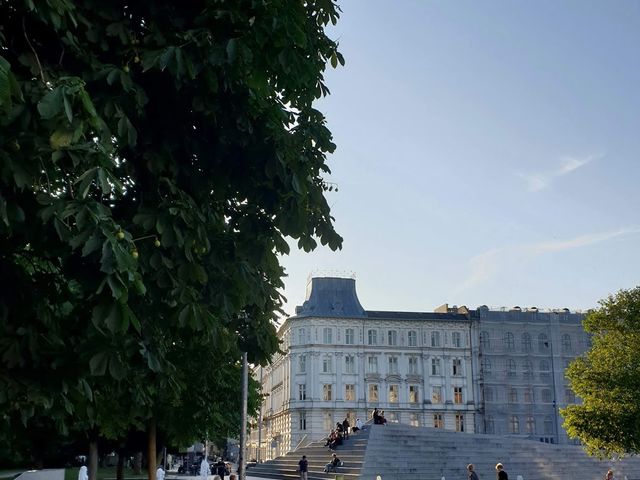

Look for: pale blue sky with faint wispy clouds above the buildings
[281,0,640,314]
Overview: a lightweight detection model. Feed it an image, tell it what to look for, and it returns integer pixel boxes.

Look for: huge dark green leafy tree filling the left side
[0,0,344,476]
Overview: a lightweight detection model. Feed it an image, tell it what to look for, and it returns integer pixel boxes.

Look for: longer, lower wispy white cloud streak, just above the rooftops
[457,226,640,293]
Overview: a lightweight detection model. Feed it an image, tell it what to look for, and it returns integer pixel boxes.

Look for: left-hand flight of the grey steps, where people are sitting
[247,426,371,480]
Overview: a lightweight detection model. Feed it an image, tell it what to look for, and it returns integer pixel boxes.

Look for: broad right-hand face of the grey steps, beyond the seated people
[360,424,640,480]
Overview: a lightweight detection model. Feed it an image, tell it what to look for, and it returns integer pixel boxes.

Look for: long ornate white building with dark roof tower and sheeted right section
[248,277,587,460]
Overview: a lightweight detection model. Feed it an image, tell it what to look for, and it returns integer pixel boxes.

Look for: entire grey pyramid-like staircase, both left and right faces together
[247,424,640,480]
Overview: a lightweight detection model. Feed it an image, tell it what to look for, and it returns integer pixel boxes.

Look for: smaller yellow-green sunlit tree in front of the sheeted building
[562,287,640,457]
